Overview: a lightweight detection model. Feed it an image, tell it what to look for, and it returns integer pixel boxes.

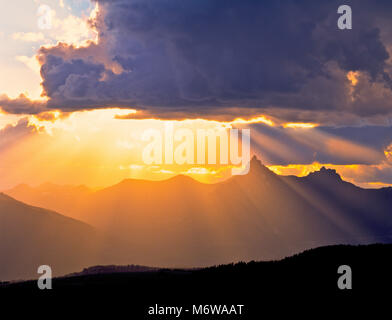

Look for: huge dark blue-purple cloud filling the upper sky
[0,0,392,122]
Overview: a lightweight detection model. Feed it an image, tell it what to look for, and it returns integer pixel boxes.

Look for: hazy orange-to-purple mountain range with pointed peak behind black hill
[0,157,392,279]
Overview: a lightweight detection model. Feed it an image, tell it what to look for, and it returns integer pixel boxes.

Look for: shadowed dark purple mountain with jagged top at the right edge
[284,168,392,240]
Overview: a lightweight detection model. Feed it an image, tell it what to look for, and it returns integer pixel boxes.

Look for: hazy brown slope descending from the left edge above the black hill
[0,193,96,280]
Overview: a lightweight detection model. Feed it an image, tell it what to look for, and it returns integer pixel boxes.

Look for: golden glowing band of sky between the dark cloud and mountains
[0,108,392,188]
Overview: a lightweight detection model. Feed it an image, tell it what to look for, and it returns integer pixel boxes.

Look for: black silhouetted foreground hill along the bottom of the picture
[0,244,392,319]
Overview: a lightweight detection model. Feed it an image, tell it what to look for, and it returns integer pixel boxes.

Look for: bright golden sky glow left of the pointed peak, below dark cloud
[0,108,245,188]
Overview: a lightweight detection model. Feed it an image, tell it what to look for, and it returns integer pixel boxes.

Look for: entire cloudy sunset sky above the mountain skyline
[0,0,392,190]
